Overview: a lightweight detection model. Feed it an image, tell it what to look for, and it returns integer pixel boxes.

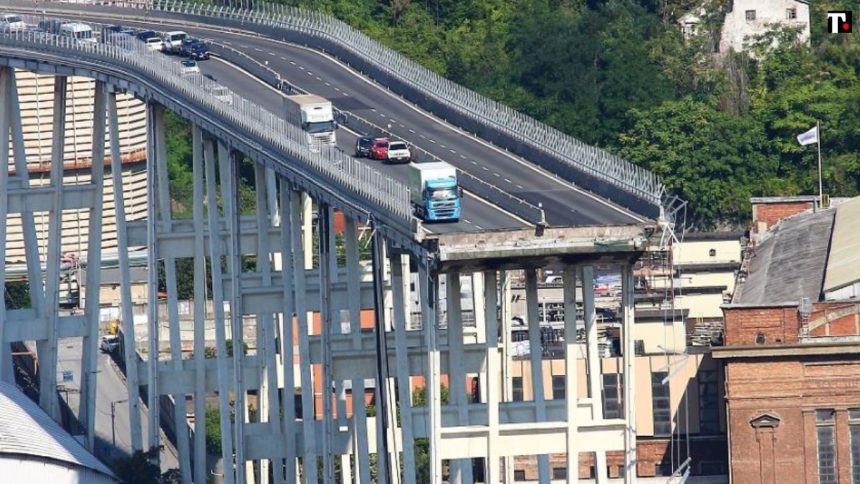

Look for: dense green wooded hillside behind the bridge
[258,0,860,228]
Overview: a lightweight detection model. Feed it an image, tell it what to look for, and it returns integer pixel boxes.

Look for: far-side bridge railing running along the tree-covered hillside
[143,0,665,217]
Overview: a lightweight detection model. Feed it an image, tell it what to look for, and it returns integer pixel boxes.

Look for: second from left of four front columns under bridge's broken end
[480,271,502,484]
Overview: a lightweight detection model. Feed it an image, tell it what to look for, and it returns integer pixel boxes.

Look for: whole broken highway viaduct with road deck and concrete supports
[0,3,662,484]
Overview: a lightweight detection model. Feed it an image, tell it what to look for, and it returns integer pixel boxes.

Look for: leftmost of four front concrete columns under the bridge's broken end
[418,259,442,484]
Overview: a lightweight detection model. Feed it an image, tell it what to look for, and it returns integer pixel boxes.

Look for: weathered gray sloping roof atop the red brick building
[733,210,835,304]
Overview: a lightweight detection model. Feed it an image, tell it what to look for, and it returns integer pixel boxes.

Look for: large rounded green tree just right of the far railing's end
[619,98,776,228]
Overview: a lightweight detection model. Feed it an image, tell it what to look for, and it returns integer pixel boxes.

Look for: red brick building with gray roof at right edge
[713,198,860,483]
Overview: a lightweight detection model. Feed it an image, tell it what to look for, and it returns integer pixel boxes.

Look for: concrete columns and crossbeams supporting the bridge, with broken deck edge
[0,61,652,483]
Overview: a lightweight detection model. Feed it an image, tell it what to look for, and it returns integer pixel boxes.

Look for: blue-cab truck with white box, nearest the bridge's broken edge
[408,161,463,222]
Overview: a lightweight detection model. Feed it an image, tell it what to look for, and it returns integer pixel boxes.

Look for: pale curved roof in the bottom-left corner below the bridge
[0,382,116,478]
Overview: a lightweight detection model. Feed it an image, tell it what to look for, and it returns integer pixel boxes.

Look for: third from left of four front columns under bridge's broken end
[562,266,585,484]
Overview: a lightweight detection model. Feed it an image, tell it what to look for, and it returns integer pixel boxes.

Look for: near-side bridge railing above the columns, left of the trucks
[0,20,412,226]
